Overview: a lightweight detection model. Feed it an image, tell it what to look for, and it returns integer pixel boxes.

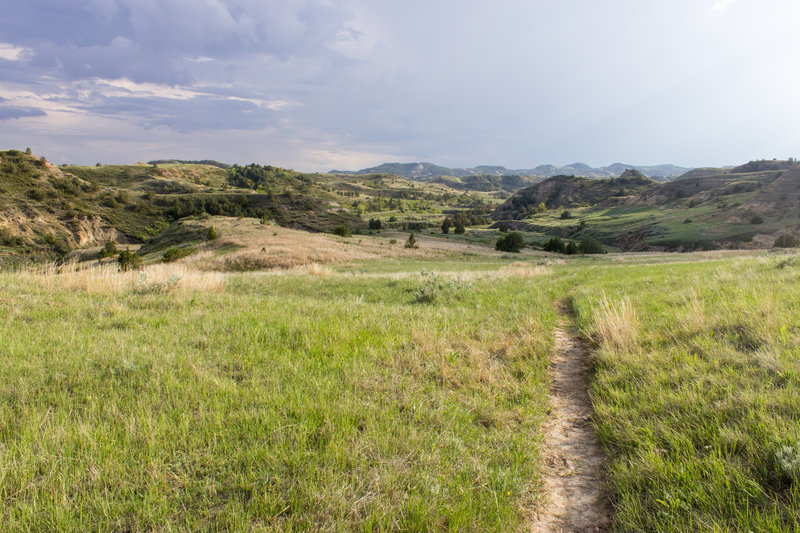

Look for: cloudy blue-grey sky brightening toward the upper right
[0,0,800,171]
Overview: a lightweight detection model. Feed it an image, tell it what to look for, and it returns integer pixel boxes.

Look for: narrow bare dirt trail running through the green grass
[528,307,609,532]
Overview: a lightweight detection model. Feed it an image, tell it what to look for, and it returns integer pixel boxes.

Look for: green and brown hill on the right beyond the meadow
[492,161,800,251]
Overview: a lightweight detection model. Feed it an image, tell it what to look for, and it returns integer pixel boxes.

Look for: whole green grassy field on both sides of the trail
[0,247,800,531]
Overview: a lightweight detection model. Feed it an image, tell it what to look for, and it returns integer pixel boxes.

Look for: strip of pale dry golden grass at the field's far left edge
[16,262,227,293]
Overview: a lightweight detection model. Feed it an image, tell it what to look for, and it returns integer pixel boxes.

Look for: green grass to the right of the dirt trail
[575,252,800,531]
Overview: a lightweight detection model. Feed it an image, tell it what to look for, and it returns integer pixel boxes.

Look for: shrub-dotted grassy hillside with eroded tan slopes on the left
[0,150,510,264]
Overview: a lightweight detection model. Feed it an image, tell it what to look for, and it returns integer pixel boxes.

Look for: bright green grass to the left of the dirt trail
[0,266,554,531]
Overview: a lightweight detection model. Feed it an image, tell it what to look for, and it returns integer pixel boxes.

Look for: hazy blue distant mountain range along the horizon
[331,163,692,181]
